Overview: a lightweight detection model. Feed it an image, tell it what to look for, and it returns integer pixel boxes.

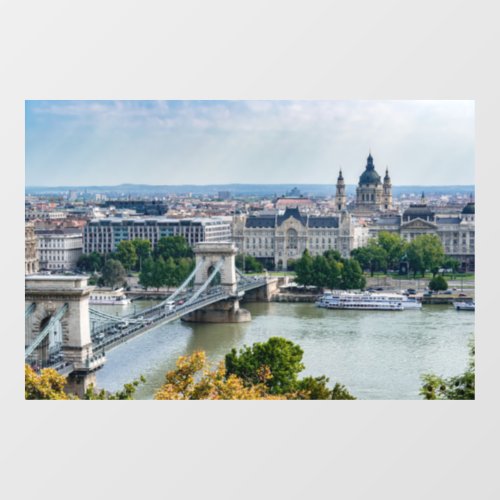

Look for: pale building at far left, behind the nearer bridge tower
[36,228,83,271]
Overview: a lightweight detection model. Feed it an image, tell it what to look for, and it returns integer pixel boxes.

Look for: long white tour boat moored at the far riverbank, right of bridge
[316,291,422,311]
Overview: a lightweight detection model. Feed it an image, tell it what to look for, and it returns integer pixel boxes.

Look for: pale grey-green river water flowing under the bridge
[97,301,474,399]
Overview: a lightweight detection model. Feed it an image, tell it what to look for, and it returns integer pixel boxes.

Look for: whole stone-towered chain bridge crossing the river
[25,243,278,394]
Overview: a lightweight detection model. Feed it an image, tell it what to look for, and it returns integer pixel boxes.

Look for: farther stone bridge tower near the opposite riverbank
[182,242,252,323]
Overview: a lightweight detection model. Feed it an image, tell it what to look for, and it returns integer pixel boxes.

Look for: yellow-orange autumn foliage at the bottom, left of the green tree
[155,352,286,400]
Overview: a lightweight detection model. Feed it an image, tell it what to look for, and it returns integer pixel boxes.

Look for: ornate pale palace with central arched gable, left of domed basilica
[233,208,367,269]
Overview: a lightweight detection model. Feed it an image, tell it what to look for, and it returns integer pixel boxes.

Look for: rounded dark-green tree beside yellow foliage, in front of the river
[226,337,304,394]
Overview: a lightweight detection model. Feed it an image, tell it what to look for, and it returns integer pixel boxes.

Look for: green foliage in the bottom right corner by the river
[420,342,476,399]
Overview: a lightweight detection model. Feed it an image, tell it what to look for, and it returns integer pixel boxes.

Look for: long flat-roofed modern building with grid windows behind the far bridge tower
[83,217,231,254]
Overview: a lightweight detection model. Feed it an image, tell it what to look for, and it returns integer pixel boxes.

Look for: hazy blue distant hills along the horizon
[25,184,474,196]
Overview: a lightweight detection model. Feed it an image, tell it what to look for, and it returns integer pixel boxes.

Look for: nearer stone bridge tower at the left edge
[25,275,105,396]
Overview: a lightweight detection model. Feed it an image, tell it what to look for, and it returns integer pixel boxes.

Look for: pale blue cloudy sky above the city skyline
[25,100,475,186]
